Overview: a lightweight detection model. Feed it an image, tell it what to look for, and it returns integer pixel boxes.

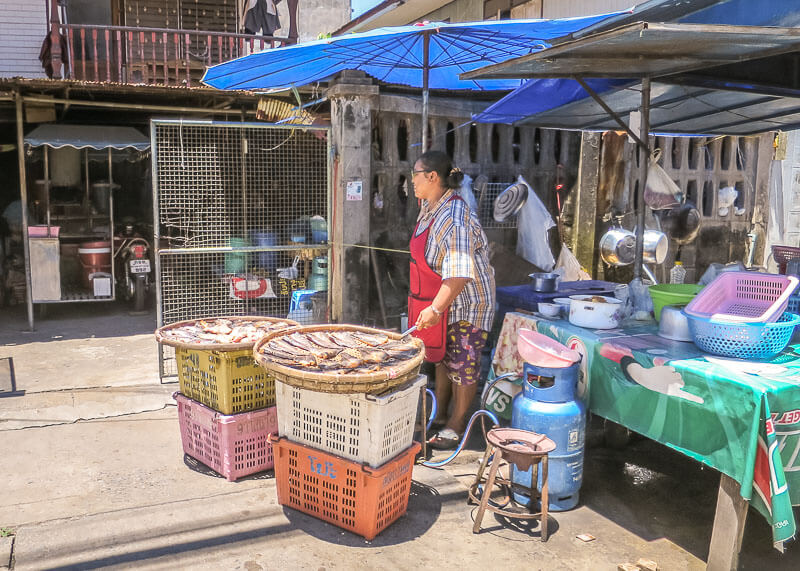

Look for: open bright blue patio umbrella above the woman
[203,12,624,148]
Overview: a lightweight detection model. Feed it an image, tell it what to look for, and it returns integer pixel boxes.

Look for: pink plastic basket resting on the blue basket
[684,272,798,323]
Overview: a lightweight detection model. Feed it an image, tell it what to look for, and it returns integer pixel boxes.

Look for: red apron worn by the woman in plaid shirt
[408,194,460,363]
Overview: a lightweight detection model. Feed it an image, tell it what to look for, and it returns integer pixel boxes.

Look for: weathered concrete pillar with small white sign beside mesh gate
[328,72,378,323]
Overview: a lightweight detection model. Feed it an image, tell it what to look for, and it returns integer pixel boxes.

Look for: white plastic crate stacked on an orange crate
[272,375,426,540]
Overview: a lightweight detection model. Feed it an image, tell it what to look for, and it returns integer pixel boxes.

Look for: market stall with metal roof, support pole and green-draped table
[461,22,800,568]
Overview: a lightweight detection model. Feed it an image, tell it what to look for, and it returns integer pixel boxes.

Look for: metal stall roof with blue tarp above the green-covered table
[465,22,800,135]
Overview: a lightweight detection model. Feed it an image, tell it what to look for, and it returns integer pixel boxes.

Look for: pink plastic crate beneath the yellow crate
[172,393,278,482]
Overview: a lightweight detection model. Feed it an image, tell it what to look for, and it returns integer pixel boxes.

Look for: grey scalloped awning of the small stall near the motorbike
[25,124,150,151]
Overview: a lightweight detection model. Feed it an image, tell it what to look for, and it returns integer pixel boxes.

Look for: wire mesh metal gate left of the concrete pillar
[150,120,331,380]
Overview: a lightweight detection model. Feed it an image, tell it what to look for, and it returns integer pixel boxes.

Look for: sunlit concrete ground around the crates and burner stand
[0,304,800,571]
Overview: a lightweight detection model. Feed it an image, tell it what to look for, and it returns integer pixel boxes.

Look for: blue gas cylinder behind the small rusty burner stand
[511,362,586,512]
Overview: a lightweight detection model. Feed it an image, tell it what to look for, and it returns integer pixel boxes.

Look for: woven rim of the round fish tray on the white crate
[253,324,425,394]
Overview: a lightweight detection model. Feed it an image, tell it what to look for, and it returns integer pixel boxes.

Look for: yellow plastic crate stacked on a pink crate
[156,318,296,481]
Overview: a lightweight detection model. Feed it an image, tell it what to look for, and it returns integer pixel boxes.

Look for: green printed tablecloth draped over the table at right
[494,313,800,542]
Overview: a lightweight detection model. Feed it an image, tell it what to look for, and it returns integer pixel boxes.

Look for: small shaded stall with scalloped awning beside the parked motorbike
[23,125,150,324]
